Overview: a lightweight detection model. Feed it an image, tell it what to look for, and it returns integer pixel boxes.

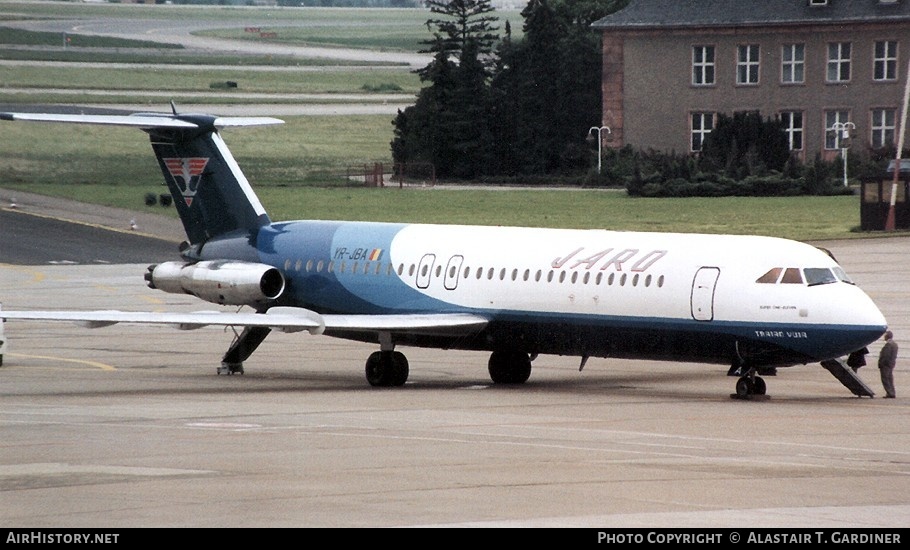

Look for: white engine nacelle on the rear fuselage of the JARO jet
[145,260,284,306]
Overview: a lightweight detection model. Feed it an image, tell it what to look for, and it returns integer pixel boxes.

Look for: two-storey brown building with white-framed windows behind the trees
[593,0,910,160]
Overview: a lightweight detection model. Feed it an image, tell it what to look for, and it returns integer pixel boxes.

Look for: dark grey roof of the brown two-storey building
[592,0,910,30]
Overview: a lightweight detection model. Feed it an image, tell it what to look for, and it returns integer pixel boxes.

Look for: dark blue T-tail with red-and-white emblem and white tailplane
[0,113,283,244]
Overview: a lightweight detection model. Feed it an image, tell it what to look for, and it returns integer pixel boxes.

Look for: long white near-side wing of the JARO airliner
[0,307,487,336]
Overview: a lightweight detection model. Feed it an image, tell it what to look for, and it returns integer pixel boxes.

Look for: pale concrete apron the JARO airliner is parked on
[0,207,910,528]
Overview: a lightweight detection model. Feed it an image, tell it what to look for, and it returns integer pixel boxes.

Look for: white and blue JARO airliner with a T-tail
[0,109,887,398]
